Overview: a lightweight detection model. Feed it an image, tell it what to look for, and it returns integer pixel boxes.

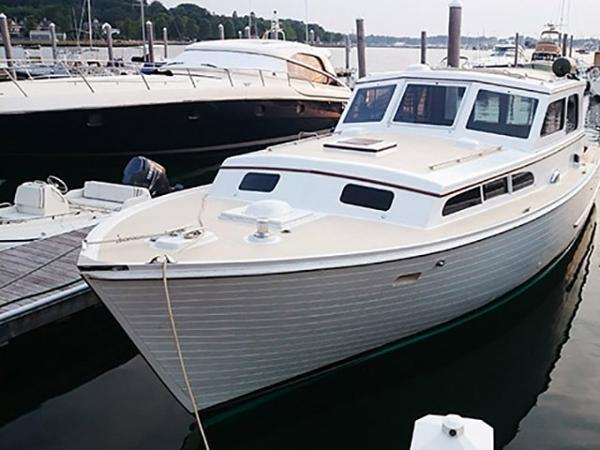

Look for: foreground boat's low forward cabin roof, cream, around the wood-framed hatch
[223,132,525,195]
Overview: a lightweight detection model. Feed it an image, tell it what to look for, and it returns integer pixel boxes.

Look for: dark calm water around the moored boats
[0,49,600,450]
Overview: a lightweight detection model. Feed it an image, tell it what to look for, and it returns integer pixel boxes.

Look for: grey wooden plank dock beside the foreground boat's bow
[0,228,97,343]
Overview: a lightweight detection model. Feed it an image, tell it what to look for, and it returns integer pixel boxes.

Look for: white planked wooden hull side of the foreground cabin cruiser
[86,169,598,410]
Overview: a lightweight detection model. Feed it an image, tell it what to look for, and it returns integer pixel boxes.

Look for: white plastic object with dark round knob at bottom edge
[410,414,494,450]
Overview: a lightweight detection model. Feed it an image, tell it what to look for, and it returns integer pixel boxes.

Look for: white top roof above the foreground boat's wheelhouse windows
[357,64,583,94]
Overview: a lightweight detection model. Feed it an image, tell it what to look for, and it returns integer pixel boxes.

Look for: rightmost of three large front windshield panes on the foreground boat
[467,89,538,139]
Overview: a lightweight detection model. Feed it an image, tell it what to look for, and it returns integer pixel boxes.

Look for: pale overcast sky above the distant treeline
[161,0,600,37]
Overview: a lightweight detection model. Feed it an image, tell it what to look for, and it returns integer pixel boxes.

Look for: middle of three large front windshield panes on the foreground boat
[394,84,465,126]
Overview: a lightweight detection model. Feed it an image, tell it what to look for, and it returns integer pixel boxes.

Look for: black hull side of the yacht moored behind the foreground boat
[0,99,344,158]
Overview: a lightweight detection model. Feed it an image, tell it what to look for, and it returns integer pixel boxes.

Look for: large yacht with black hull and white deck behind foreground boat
[0,39,350,158]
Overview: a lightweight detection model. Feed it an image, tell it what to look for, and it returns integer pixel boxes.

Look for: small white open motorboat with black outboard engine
[0,157,172,251]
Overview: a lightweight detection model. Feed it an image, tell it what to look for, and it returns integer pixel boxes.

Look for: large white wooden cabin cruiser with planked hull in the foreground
[79,61,599,410]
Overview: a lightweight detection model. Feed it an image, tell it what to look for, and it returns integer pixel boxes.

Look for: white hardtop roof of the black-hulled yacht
[185,39,330,60]
